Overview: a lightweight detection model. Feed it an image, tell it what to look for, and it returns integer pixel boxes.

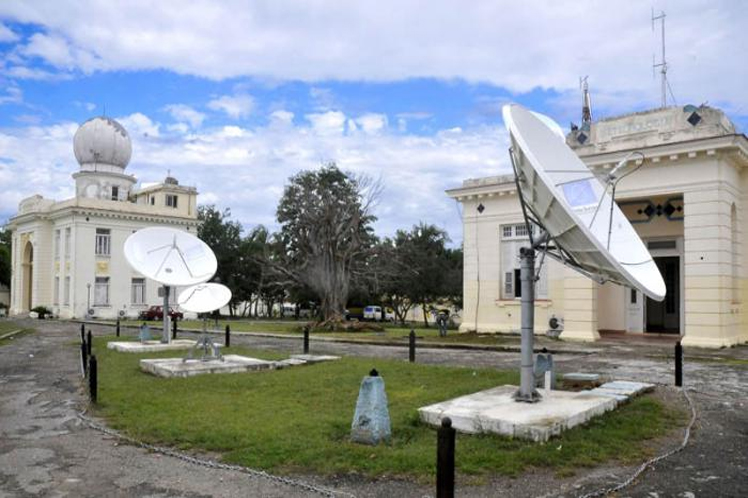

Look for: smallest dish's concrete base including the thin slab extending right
[140,354,340,377]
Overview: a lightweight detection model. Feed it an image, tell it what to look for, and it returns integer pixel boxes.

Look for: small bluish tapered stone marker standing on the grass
[351,369,392,445]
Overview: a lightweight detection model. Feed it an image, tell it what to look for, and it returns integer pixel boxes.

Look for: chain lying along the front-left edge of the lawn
[76,411,356,498]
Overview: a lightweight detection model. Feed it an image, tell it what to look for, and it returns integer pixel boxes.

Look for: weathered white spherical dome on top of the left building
[73,117,132,168]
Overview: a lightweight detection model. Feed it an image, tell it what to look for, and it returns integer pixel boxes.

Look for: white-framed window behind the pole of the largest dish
[500,224,548,299]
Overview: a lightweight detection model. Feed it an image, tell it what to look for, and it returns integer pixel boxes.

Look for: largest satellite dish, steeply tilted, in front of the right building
[502,104,665,301]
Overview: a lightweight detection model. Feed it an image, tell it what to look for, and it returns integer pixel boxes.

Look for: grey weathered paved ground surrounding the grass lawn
[0,321,748,498]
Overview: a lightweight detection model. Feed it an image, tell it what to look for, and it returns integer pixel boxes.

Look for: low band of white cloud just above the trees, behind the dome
[0,115,508,243]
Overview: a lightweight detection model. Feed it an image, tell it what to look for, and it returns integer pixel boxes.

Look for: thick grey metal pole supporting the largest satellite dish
[514,247,540,403]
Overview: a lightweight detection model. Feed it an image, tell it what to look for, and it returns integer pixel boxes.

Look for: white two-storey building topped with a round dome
[8,117,198,318]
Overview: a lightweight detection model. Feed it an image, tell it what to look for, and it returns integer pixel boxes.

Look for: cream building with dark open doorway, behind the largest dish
[447,106,748,347]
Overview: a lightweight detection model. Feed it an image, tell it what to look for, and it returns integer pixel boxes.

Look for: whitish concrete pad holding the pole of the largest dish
[418,386,618,441]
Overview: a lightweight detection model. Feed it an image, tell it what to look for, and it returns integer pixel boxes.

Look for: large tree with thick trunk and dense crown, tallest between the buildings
[274,163,381,324]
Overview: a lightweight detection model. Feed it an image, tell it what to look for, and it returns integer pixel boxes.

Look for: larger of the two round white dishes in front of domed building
[125,227,218,286]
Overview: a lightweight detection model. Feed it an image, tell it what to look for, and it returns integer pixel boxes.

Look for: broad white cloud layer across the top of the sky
[0,0,748,114]
